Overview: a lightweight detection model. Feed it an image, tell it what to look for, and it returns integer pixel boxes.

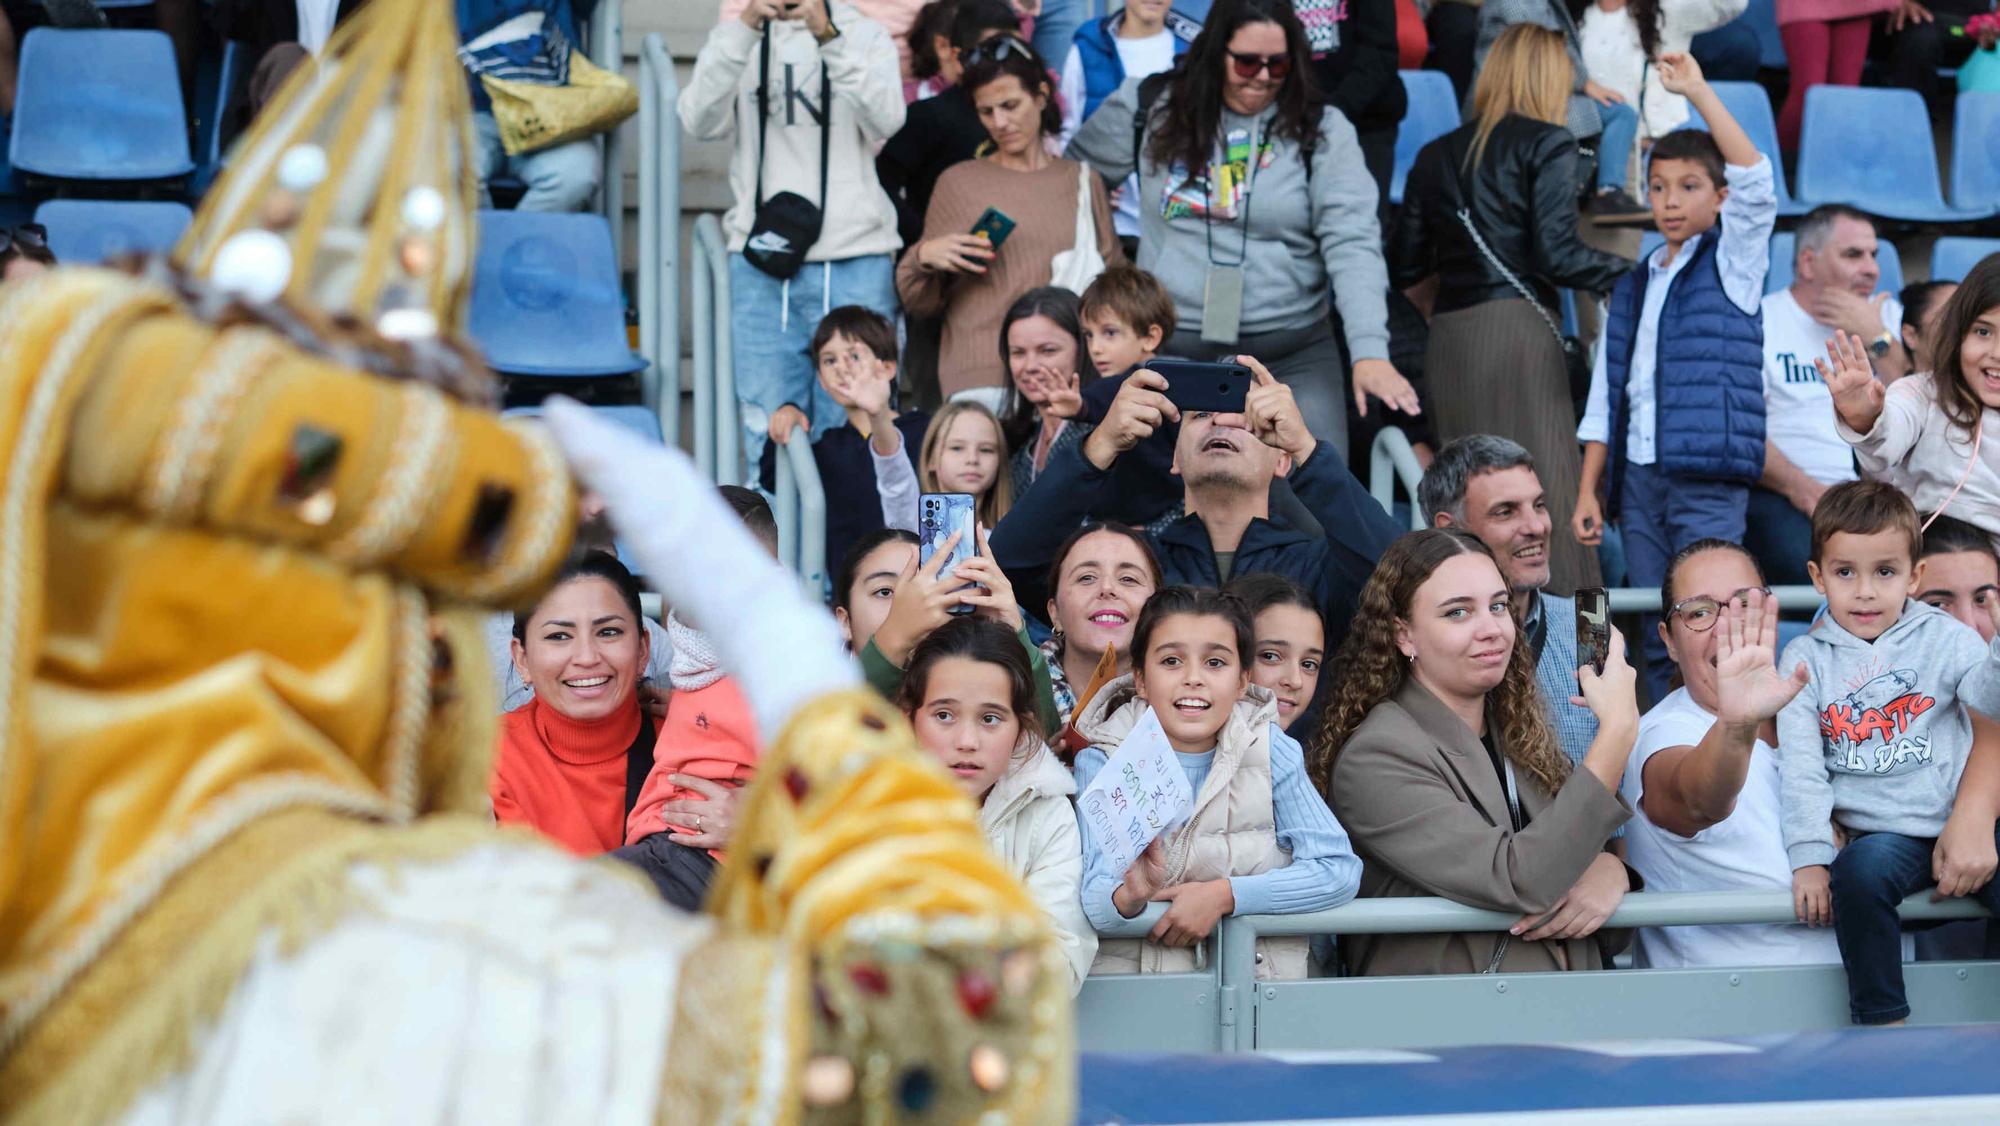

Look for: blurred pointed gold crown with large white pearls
[174,0,478,340]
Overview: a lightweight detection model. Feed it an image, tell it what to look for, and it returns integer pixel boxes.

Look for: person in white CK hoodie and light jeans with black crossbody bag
[678,0,904,480]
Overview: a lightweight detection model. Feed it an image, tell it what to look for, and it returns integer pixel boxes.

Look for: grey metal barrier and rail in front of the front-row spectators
[1076,890,2000,1052]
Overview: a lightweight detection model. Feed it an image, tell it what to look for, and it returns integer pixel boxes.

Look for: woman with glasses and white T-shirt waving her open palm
[1622,540,1848,966]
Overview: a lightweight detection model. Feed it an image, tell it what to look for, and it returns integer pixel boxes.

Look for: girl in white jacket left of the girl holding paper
[896,618,1098,990]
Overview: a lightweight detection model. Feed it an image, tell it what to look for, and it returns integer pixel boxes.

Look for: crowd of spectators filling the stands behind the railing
[62,0,2000,1024]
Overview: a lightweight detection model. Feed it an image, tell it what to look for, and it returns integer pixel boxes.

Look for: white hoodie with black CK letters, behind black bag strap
[680,0,904,262]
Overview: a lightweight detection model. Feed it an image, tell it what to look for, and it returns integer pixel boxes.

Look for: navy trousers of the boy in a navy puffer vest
[1618,462,1750,700]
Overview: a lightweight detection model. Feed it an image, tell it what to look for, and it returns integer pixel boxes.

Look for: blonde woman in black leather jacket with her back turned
[1390,24,1632,594]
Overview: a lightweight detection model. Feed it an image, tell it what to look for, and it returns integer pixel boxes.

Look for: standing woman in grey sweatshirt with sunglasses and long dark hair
[1070,0,1416,458]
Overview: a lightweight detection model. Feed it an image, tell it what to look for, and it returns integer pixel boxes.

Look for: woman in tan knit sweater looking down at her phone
[896,36,1124,398]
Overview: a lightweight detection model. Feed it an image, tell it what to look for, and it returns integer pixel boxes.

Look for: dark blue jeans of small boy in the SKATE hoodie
[1828,832,2000,1024]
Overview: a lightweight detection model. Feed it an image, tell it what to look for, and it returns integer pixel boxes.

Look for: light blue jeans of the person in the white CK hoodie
[730,254,896,482]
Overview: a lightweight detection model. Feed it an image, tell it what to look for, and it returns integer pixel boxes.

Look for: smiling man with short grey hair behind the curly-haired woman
[1416,434,1598,762]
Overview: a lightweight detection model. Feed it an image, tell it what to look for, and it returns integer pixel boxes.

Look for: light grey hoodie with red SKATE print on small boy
[1778,598,2000,868]
